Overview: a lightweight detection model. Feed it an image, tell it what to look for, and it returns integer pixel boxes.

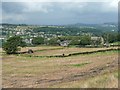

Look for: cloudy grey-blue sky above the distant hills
[0,0,118,25]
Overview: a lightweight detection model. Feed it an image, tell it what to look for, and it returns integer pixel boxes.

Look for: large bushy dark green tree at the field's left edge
[3,36,26,54]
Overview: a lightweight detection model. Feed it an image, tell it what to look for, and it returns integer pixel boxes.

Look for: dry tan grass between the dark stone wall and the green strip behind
[26,47,117,56]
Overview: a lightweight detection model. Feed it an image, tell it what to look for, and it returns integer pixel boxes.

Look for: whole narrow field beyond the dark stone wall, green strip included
[21,46,117,56]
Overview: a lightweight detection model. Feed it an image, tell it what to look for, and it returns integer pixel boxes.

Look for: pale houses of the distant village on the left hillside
[0,25,64,44]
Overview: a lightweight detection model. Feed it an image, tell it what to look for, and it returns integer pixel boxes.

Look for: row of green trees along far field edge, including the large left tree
[2,33,120,54]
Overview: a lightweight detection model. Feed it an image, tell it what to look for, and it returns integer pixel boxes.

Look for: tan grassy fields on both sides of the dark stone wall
[2,46,118,88]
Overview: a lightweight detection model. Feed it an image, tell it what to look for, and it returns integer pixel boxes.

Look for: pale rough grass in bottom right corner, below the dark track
[50,71,118,88]
